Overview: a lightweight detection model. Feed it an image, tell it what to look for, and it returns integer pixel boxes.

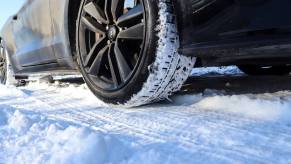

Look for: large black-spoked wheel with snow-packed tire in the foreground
[76,0,195,106]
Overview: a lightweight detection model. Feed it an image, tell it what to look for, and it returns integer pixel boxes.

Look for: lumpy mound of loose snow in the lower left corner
[0,109,127,164]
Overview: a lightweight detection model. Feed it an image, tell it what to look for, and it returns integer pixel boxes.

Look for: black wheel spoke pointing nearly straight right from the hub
[117,23,144,40]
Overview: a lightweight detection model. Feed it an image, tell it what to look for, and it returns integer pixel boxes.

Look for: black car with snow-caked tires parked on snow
[0,0,291,106]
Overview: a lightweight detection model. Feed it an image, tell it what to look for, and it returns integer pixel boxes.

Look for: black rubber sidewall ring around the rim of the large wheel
[76,0,159,104]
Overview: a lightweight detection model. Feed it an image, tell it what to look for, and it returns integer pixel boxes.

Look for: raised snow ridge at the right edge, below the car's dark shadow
[195,93,291,123]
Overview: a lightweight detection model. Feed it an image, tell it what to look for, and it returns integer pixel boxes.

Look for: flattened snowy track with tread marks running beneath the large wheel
[1,84,291,163]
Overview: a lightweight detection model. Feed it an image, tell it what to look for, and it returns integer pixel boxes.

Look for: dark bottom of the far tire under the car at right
[238,65,291,75]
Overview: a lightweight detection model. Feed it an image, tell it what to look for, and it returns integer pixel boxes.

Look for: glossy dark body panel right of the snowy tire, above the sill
[175,0,291,59]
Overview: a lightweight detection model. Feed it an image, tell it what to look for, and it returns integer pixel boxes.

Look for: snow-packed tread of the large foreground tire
[125,0,195,107]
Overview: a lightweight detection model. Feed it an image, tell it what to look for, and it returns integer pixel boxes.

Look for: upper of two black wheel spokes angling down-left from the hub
[84,37,106,67]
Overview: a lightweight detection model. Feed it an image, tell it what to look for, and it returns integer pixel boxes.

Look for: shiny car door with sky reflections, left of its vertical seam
[12,0,56,70]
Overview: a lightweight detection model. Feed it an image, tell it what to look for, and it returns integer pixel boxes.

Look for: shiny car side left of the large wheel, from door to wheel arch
[1,0,76,73]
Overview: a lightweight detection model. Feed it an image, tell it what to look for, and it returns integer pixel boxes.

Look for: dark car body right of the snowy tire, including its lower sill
[176,0,291,66]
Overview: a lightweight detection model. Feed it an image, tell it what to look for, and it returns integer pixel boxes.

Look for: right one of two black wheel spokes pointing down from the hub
[114,43,131,82]
